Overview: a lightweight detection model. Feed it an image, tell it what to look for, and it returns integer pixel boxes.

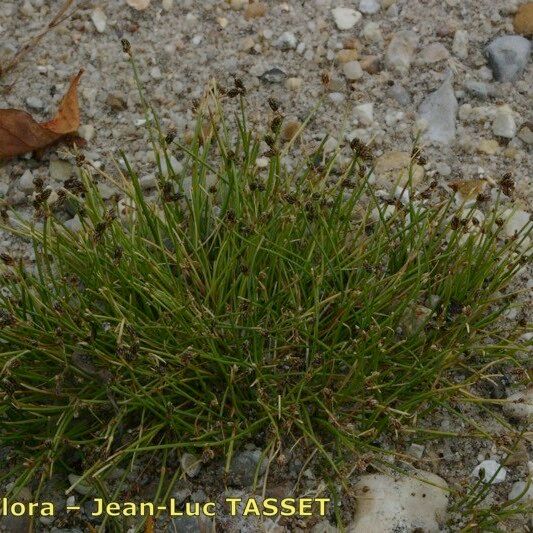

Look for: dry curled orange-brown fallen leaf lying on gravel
[0,69,83,159]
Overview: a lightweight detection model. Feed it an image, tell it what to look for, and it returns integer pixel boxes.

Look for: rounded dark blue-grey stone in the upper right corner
[485,35,531,81]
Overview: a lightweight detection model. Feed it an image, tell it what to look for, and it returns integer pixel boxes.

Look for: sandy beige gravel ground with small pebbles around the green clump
[0,0,533,532]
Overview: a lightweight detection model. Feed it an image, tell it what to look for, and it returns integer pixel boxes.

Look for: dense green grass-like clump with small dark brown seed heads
[0,76,525,508]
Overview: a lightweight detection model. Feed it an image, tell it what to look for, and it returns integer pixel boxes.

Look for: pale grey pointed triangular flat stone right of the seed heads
[418,76,458,144]
